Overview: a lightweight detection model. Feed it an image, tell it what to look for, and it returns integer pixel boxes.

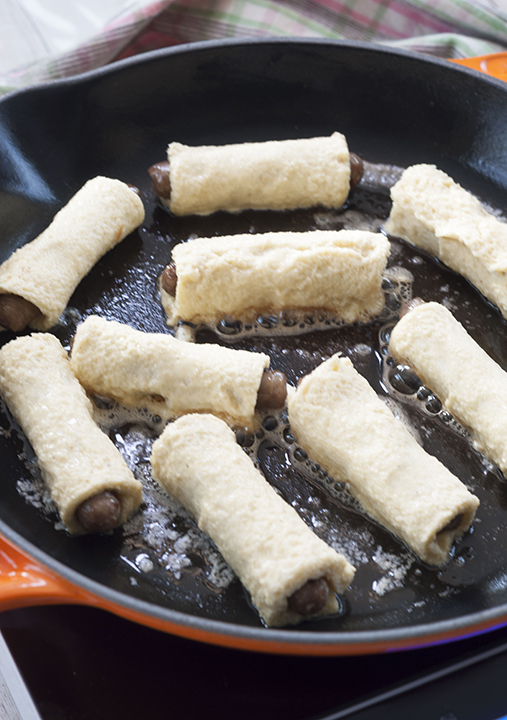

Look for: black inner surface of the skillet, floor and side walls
[0,42,507,634]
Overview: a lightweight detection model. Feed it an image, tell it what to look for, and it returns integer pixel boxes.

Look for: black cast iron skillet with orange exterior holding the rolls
[0,39,507,654]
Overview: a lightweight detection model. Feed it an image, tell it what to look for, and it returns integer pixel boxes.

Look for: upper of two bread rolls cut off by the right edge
[386,165,507,317]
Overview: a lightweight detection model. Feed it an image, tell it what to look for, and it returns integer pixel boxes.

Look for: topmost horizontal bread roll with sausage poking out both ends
[149,132,362,215]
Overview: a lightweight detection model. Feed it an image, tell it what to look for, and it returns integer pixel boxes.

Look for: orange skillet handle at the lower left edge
[0,535,91,611]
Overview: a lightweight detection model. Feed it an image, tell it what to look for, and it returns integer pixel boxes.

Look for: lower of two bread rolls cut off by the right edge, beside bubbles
[389,302,507,473]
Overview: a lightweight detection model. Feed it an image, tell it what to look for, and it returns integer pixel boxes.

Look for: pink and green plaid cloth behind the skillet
[0,0,507,94]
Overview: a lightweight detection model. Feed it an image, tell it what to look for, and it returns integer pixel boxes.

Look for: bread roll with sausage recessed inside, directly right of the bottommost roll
[288,355,479,565]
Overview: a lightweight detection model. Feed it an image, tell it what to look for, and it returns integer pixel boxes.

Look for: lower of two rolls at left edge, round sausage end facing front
[0,333,142,533]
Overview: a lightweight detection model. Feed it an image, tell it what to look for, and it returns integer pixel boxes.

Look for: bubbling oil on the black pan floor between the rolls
[0,159,507,631]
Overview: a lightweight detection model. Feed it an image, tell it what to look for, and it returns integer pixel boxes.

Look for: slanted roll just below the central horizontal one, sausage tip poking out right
[71,316,286,427]
